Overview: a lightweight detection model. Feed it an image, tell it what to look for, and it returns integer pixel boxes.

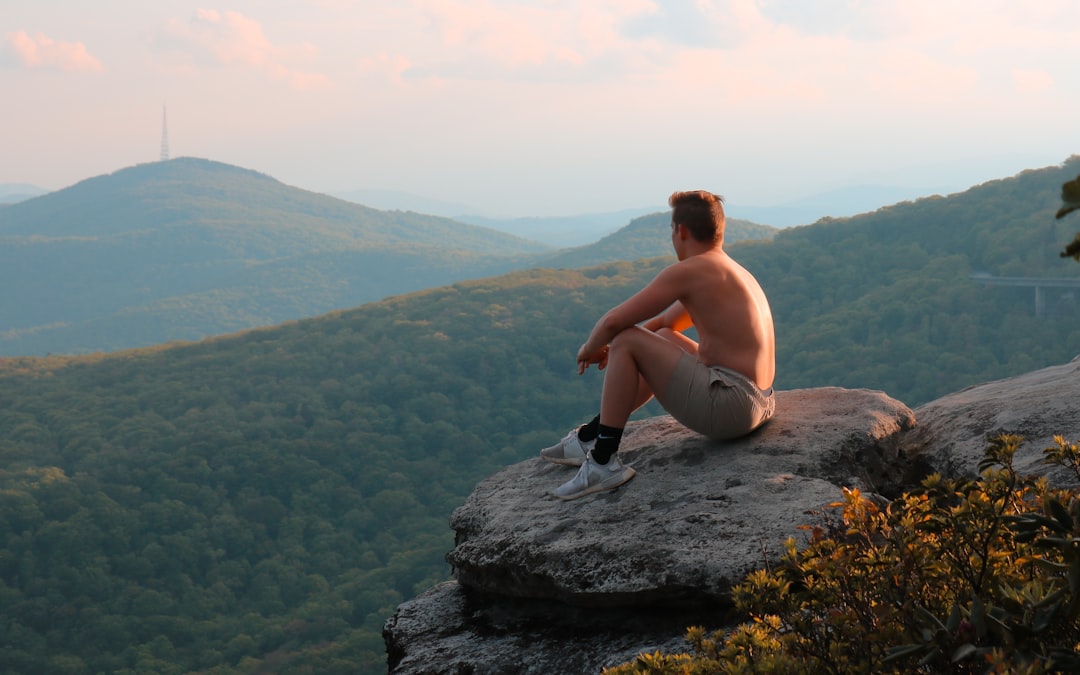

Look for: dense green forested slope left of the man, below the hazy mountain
[0,261,659,673]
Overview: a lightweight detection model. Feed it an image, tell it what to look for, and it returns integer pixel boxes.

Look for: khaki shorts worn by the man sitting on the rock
[658,352,777,441]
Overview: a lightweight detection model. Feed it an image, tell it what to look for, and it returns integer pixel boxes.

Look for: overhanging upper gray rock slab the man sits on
[447,388,915,607]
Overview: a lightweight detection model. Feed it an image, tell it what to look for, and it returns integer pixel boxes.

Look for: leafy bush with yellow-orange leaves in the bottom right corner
[605,435,1080,675]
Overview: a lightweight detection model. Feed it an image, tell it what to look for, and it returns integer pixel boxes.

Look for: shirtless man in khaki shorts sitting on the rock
[540,190,775,499]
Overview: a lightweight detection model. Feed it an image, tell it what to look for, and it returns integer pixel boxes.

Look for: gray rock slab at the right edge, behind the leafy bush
[903,356,1080,487]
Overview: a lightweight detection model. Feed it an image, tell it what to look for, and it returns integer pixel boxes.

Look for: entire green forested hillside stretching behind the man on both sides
[6,159,1080,673]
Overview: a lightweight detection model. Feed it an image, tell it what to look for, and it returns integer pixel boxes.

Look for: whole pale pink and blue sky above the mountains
[0,0,1080,216]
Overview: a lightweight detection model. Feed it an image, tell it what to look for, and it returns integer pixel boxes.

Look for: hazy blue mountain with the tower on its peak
[0,158,548,354]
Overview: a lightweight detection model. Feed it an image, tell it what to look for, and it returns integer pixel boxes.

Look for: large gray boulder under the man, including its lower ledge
[384,388,915,674]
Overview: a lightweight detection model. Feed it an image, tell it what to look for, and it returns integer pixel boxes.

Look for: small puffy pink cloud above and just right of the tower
[163,9,330,90]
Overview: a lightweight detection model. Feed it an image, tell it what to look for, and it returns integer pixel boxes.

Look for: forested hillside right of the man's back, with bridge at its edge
[756,157,1080,406]
